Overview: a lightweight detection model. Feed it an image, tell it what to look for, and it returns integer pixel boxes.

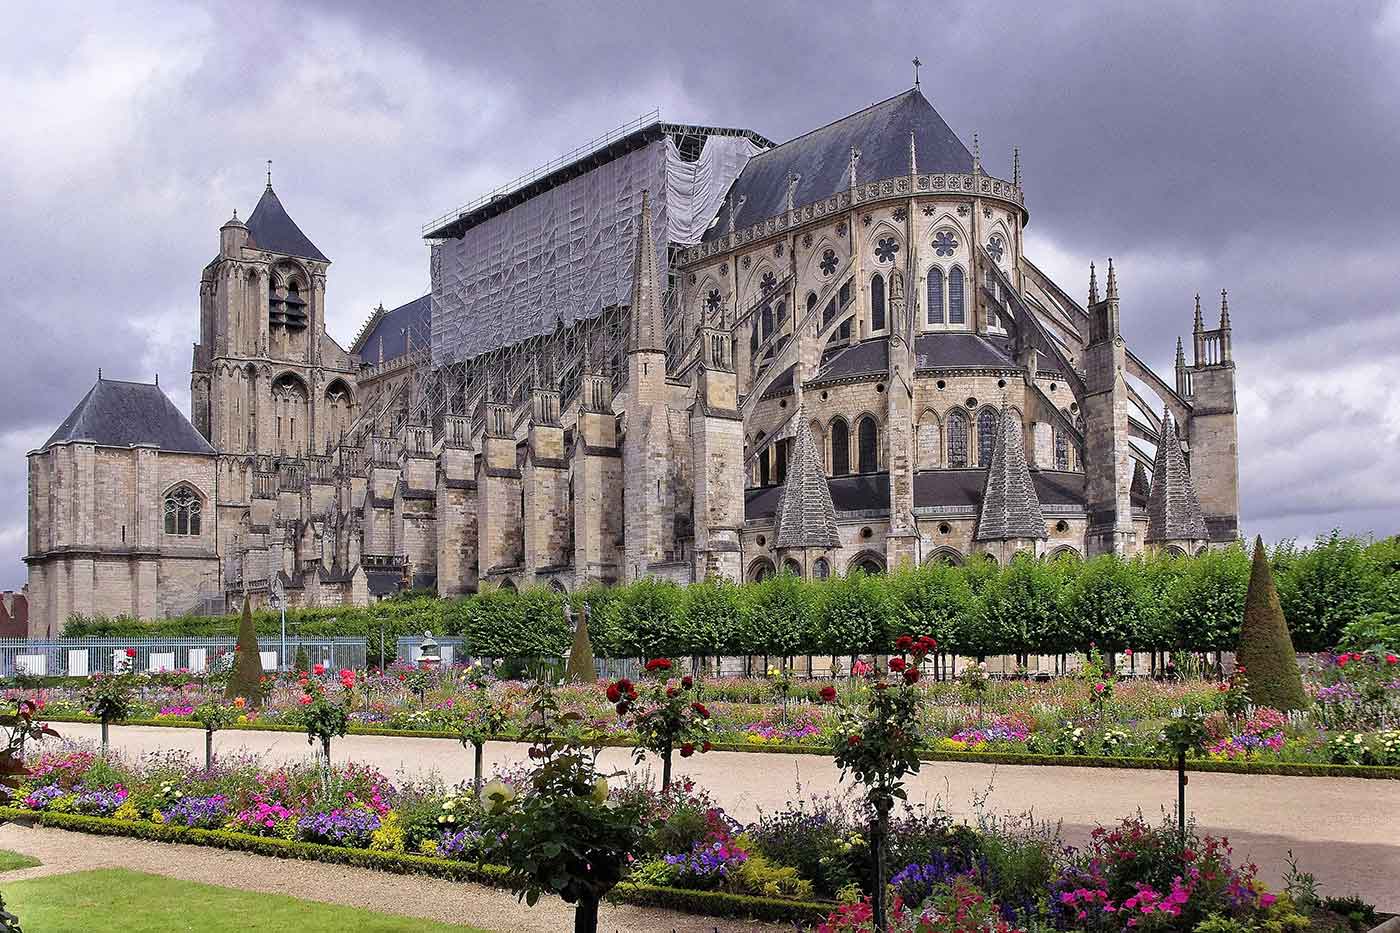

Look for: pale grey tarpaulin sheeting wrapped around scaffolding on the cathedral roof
[427,123,766,367]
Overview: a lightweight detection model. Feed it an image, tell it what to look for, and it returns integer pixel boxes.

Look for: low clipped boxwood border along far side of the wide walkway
[45,713,1400,780]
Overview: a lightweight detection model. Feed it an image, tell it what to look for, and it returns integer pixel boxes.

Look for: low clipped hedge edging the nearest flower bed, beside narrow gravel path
[0,807,834,923]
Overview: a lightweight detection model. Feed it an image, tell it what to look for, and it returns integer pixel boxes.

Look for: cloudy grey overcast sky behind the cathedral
[0,0,1400,588]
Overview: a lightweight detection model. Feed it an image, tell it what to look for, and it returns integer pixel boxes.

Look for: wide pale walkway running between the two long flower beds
[43,723,1400,907]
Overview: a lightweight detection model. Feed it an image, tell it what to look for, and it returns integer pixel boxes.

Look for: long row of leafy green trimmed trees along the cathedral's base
[66,532,1400,660]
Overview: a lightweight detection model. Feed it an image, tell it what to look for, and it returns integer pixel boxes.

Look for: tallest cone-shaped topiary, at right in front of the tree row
[1236,538,1308,710]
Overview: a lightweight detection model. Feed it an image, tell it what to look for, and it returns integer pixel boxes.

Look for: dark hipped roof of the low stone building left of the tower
[43,378,214,454]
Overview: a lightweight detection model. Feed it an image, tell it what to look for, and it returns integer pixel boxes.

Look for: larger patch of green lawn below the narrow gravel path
[4,869,486,933]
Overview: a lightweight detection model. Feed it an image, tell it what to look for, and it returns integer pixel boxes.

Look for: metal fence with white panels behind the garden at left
[0,636,365,677]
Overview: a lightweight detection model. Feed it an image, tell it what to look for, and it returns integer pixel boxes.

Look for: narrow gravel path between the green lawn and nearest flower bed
[0,824,781,933]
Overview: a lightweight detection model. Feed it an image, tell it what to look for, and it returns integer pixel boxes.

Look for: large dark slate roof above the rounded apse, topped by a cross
[704,87,972,241]
